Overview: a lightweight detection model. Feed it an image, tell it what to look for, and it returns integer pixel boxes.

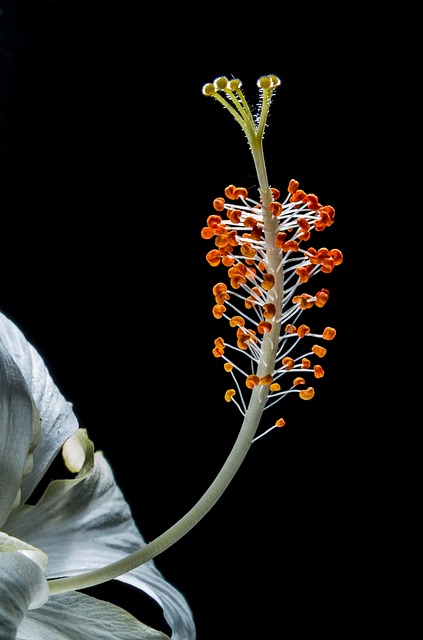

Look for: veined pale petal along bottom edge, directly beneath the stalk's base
[18,591,169,640]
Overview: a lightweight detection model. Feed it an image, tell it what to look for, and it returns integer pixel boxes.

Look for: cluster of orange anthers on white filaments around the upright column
[201,180,342,426]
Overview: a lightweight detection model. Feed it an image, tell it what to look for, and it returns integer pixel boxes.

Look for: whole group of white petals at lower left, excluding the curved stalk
[0,313,196,640]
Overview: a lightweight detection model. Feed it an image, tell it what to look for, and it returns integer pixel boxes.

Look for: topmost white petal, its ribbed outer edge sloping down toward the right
[0,313,78,501]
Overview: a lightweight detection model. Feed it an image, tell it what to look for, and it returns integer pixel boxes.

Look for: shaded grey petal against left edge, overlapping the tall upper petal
[0,339,39,527]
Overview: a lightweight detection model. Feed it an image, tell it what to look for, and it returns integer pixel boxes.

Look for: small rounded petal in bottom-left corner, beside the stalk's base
[0,551,48,640]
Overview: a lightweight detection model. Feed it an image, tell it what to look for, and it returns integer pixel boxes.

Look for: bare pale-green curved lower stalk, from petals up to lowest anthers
[49,388,265,595]
